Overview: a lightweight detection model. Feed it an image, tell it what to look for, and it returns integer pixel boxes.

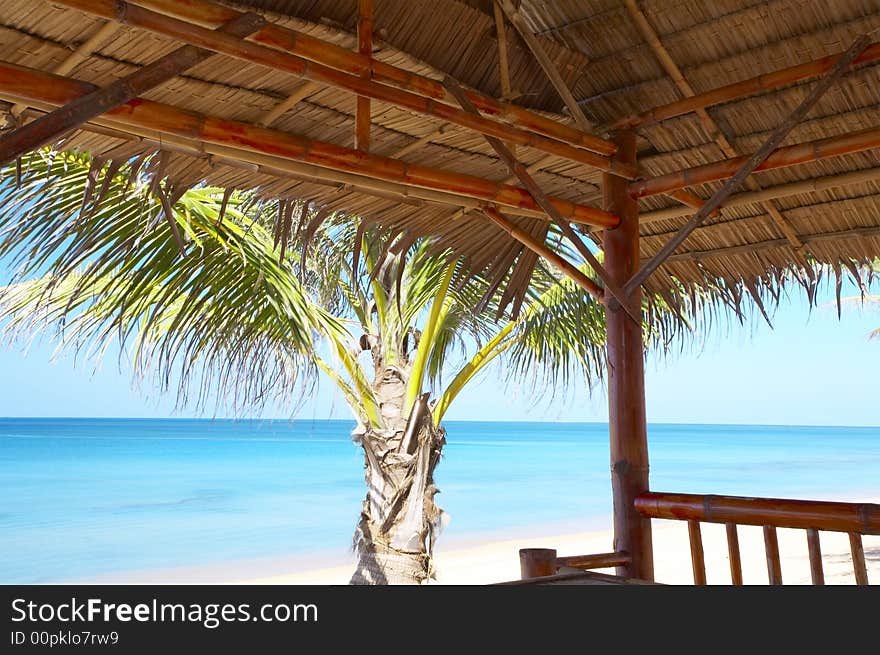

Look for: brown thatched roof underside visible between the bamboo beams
[0,0,880,312]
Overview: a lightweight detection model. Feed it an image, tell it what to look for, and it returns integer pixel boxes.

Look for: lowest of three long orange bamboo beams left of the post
[0,62,618,228]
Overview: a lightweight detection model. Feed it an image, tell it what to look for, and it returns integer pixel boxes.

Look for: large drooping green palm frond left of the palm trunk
[0,151,335,407]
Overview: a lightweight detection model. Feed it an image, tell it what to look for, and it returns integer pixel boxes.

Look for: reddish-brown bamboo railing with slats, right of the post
[635,492,880,585]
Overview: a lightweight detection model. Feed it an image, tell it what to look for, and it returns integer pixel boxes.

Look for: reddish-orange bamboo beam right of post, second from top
[629,128,880,198]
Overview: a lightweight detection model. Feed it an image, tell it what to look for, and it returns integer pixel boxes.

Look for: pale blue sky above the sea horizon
[0,276,880,426]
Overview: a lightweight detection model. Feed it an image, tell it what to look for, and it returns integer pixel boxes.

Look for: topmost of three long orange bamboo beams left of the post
[59,0,623,159]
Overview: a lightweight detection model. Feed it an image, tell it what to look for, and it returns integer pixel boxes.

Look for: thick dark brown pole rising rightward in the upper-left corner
[0,13,265,166]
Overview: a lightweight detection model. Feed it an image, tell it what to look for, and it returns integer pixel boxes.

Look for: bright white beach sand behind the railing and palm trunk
[241,516,880,584]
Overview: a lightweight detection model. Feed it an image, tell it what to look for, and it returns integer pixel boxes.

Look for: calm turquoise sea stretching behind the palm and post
[0,419,880,583]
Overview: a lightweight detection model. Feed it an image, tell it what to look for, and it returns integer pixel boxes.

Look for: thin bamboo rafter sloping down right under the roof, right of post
[626,0,804,250]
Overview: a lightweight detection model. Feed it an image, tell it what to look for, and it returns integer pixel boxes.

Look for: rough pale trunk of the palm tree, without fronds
[350,369,445,584]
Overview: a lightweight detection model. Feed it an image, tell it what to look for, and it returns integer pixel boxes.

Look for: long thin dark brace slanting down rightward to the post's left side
[444,76,642,324]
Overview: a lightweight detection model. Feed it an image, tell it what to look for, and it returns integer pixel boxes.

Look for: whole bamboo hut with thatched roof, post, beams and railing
[0,0,880,583]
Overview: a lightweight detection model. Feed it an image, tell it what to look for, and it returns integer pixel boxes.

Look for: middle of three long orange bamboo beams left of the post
[58,0,624,173]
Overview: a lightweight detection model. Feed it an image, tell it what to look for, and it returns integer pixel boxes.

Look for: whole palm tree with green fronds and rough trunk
[0,151,685,584]
